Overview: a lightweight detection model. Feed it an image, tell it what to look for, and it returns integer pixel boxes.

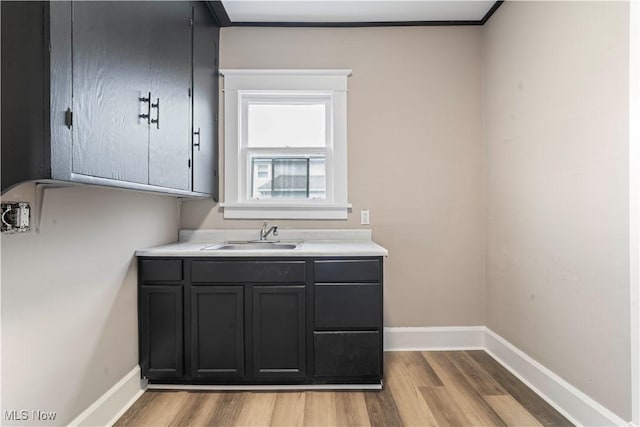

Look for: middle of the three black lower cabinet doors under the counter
[191,285,245,379]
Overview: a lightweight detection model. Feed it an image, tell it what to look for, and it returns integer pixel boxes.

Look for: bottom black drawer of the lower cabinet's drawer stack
[313,331,381,377]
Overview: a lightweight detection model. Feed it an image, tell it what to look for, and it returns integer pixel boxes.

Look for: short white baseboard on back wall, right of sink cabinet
[384,326,486,351]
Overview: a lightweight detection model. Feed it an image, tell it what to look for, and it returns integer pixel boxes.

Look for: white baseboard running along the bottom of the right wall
[484,328,629,426]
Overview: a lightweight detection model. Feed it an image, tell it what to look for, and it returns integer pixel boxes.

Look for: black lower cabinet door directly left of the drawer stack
[252,285,306,379]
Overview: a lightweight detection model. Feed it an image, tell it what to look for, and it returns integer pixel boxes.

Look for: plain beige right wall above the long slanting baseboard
[483,2,631,420]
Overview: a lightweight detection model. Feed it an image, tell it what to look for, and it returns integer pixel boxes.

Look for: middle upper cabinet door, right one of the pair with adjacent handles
[148,1,191,190]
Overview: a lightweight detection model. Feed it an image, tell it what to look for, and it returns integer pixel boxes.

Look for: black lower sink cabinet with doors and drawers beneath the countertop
[139,257,382,384]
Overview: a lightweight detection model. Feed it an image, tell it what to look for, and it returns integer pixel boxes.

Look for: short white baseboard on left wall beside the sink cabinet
[69,366,144,426]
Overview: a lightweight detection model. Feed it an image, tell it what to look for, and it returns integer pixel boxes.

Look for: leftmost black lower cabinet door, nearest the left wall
[140,285,184,379]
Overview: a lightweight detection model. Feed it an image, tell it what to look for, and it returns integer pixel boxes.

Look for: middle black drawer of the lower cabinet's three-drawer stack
[315,283,381,329]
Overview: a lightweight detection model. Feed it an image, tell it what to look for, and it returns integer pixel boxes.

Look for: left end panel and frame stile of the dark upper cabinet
[0,1,72,193]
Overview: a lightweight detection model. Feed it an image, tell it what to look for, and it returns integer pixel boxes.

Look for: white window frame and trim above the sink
[220,69,351,219]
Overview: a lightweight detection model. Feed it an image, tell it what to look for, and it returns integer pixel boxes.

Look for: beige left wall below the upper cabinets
[0,184,179,425]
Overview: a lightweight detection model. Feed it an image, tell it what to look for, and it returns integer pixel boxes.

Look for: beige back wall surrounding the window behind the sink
[182,27,484,326]
